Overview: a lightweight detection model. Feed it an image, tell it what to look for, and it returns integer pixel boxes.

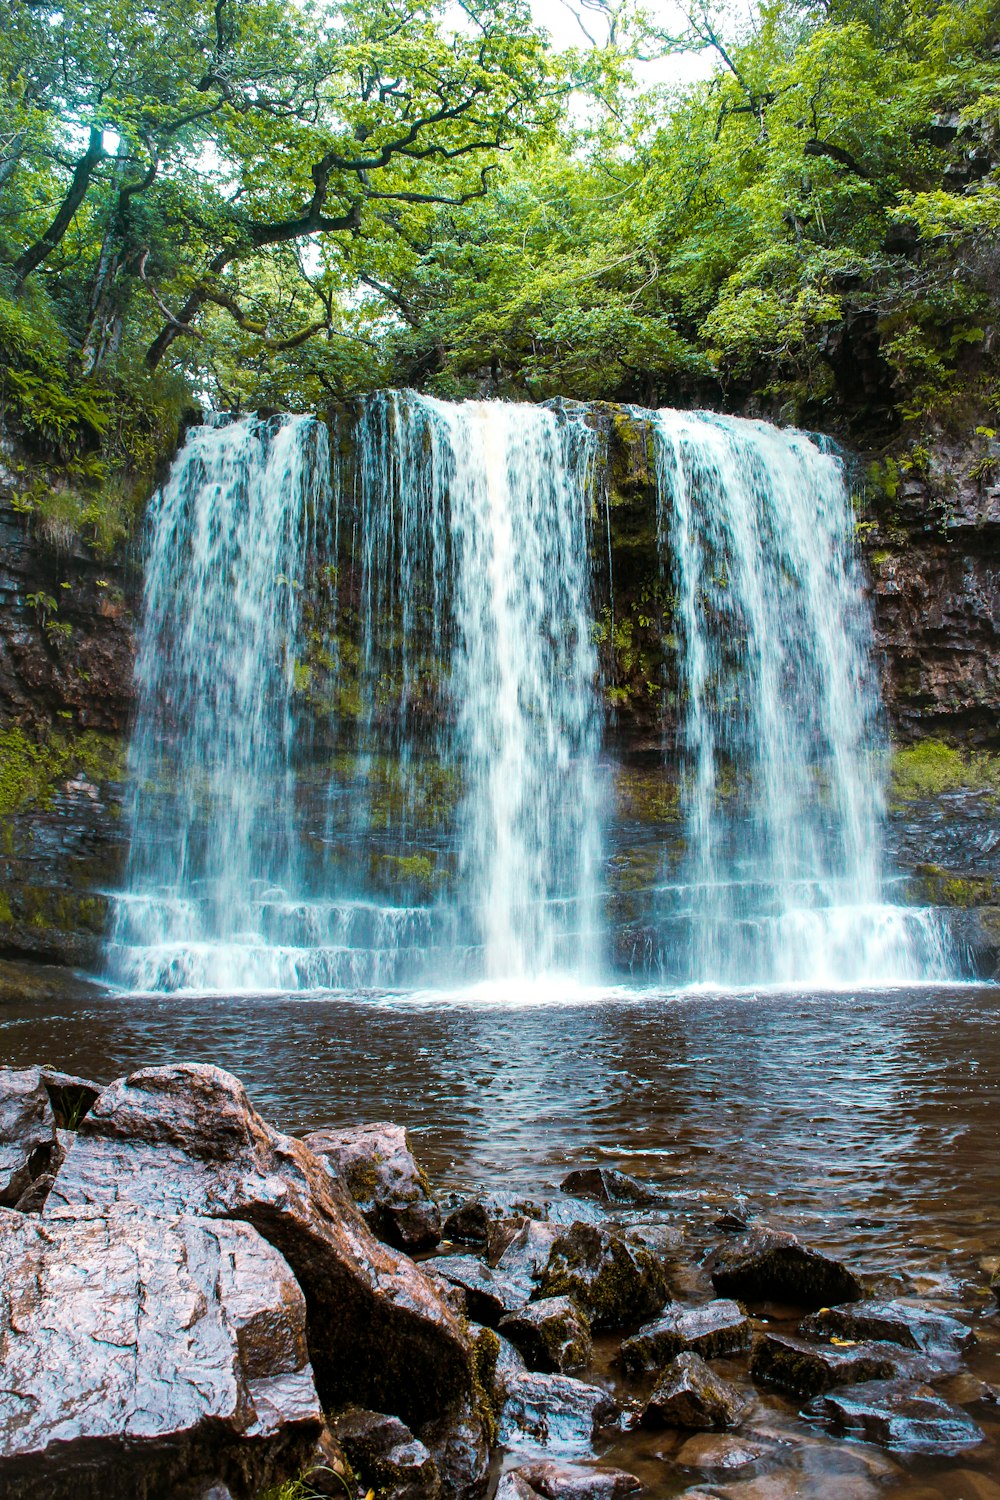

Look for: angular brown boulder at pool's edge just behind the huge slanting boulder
[304,1125,441,1253]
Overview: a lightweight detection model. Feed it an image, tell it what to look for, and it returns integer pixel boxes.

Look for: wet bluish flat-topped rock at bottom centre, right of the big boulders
[499,1371,619,1458]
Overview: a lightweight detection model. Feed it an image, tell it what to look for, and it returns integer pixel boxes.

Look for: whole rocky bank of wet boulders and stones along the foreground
[0,1064,1000,1500]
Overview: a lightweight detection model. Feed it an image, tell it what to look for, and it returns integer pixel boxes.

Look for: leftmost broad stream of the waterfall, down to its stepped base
[108,417,330,990]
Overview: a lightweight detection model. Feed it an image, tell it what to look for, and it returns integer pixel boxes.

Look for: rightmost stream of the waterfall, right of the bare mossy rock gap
[654,411,948,986]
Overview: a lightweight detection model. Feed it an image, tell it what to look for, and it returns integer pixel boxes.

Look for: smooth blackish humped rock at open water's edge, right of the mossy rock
[712,1226,865,1307]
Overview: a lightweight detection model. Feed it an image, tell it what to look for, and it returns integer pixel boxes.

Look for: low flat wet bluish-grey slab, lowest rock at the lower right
[802,1380,985,1455]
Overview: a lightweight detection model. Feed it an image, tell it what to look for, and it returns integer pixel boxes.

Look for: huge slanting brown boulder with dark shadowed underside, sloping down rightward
[45,1064,486,1488]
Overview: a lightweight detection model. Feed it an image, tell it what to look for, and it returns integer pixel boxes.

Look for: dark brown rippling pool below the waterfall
[0,987,1000,1500]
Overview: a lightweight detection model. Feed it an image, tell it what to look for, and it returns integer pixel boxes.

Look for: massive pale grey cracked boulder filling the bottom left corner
[0,1209,322,1500]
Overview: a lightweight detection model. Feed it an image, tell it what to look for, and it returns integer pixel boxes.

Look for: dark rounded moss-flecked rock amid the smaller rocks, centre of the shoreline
[541,1224,669,1328]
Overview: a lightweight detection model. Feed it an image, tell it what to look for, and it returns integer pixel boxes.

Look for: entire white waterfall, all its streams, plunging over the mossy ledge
[108,393,949,995]
